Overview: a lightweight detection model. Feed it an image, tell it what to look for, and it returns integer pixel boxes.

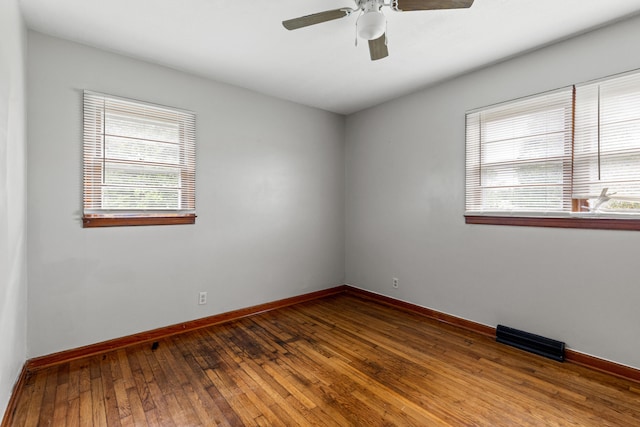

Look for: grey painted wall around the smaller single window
[28,32,344,357]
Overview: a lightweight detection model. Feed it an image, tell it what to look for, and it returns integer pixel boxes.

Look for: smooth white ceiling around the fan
[21,0,640,114]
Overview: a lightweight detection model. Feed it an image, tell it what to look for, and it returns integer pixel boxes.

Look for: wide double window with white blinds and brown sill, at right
[465,69,640,229]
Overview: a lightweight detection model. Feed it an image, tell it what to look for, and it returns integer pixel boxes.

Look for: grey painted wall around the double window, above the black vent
[346,18,640,368]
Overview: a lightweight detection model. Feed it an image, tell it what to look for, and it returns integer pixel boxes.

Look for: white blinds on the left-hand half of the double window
[466,88,573,215]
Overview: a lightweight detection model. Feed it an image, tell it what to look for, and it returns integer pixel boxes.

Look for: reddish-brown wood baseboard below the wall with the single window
[25,285,346,372]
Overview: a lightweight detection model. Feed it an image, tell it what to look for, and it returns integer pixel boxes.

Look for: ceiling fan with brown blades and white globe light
[282,0,473,61]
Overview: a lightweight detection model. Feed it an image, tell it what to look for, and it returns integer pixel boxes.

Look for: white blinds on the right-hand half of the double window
[573,72,640,214]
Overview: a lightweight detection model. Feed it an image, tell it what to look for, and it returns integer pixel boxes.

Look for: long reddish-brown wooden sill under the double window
[465,215,640,230]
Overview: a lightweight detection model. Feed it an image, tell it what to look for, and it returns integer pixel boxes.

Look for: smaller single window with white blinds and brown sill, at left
[83,91,196,227]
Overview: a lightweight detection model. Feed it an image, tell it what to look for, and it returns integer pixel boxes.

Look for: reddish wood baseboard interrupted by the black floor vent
[346,285,640,383]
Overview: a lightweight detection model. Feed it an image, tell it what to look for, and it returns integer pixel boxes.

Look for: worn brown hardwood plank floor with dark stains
[6,294,640,427]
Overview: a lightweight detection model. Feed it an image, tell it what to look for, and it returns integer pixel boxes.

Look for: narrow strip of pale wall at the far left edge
[0,0,27,419]
